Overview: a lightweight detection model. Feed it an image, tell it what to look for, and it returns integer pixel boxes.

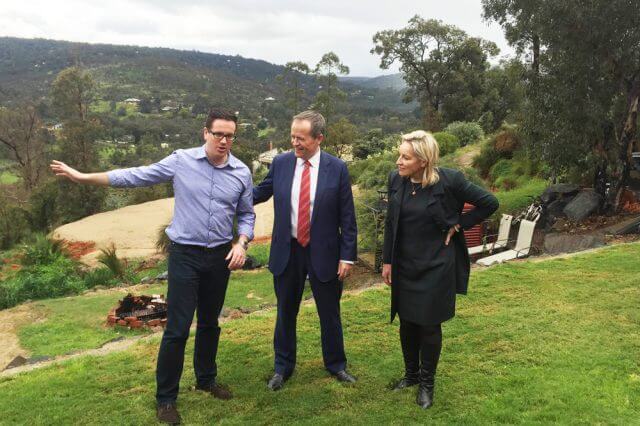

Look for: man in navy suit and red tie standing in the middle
[253,111,357,391]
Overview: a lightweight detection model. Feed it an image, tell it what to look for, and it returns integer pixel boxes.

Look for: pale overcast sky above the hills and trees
[0,0,513,76]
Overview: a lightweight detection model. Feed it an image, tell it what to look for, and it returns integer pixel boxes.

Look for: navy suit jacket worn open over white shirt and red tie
[253,151,357,282]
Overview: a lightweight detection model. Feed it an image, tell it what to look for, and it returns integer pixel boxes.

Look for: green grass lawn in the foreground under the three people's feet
[0,243,640,425]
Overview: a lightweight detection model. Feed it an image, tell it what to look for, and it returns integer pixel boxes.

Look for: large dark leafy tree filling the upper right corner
[483,0,640,211]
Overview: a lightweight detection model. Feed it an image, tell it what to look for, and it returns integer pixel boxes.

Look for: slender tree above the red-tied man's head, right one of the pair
[314,52,349,123]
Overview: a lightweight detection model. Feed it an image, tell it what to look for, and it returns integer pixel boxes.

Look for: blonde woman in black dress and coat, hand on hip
[382,130,498,408]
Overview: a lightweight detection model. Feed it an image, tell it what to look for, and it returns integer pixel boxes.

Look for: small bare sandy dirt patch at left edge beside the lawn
[0,303,44,371]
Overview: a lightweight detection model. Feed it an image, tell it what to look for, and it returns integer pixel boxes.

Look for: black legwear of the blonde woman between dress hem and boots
[400,319,442,377]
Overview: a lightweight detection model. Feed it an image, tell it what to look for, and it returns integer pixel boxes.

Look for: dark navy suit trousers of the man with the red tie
[273,239,347,377]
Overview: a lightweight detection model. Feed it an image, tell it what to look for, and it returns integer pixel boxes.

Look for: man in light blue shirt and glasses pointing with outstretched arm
[51,110,255,423]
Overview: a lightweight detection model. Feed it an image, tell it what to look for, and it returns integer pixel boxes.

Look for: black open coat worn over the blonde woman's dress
[383,168,498,321]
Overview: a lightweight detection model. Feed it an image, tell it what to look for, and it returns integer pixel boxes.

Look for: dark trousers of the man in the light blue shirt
[156,243,231,403]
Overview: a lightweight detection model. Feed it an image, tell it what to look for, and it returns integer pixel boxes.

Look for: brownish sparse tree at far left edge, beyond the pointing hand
[0,105,46,192]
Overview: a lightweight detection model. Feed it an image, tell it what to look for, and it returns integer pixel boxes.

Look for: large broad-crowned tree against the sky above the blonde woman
[371,15,499,130]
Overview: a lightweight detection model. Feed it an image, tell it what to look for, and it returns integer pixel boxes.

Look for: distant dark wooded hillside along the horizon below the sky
[0,37,410,115]
